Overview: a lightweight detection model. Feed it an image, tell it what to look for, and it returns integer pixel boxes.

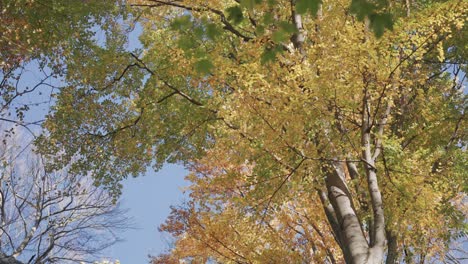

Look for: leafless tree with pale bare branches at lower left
[0,129,130,263]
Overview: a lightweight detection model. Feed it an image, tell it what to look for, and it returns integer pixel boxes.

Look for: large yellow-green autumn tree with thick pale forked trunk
[38,0,467,263]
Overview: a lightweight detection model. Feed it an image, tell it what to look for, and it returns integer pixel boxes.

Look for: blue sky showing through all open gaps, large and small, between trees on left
[4,21,188,264]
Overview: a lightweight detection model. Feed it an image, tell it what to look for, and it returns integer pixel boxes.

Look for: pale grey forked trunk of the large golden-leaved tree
[324,88,395,264]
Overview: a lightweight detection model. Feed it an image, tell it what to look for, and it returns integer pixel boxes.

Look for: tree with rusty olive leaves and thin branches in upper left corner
[0,0,126,132]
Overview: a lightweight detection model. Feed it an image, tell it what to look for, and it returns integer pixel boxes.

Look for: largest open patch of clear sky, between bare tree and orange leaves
[108,164,187,264]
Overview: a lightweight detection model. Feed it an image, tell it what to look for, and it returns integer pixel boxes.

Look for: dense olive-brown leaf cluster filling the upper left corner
[0,0,125,69]
